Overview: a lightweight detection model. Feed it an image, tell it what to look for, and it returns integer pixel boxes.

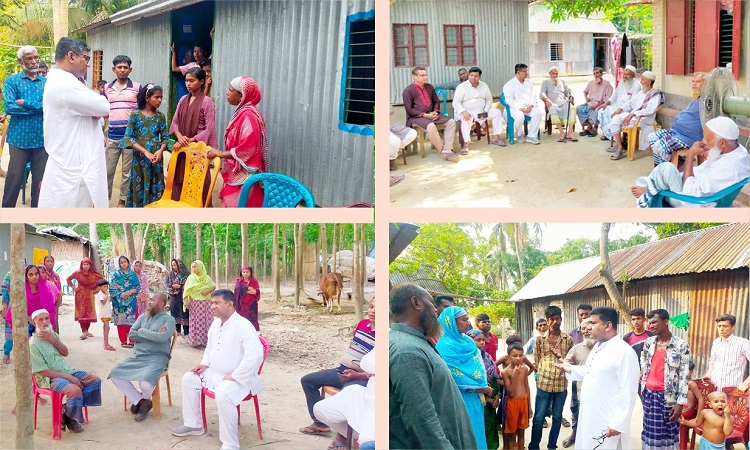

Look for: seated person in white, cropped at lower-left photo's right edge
[313,348,375,449]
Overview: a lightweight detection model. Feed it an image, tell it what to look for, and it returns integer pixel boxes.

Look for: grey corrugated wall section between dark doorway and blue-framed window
[213,0,375,206]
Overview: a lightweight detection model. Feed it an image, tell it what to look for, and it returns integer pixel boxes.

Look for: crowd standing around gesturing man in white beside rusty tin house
[389,284,750,450]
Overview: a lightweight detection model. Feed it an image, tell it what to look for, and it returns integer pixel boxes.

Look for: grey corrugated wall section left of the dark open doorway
[87,14,172,112]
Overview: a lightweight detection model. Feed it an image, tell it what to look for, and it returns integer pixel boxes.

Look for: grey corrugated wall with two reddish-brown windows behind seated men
[389,0,529,104]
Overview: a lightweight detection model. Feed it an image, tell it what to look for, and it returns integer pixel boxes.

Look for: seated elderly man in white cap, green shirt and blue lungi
[29,309,102,433]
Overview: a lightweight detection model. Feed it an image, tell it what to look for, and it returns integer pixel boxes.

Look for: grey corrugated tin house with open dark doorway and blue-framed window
[78,0,375,206]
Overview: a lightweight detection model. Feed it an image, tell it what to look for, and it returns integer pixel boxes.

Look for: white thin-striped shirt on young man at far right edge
[709,334,750,390]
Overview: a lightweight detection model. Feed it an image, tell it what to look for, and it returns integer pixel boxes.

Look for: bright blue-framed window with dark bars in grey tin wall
[339,10,375,136]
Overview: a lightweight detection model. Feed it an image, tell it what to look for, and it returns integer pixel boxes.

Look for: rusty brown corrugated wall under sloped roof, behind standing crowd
[516,268,750,377]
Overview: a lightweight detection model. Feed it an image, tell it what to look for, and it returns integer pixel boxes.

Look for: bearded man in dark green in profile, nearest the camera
[388,283,477,449]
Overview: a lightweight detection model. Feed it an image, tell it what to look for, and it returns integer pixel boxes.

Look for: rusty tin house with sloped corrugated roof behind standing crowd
[510,223,750,374]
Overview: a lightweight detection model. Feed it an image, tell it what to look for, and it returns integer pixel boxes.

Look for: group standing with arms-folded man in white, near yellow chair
[2,37,269,208]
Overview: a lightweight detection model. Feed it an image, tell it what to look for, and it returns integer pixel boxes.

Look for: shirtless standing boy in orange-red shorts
[503,343,532,450]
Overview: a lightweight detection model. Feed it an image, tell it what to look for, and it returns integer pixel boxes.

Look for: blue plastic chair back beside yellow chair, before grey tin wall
[237,172,315,208]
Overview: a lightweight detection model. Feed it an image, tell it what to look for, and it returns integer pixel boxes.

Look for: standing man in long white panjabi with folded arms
[39,37,109,208]
